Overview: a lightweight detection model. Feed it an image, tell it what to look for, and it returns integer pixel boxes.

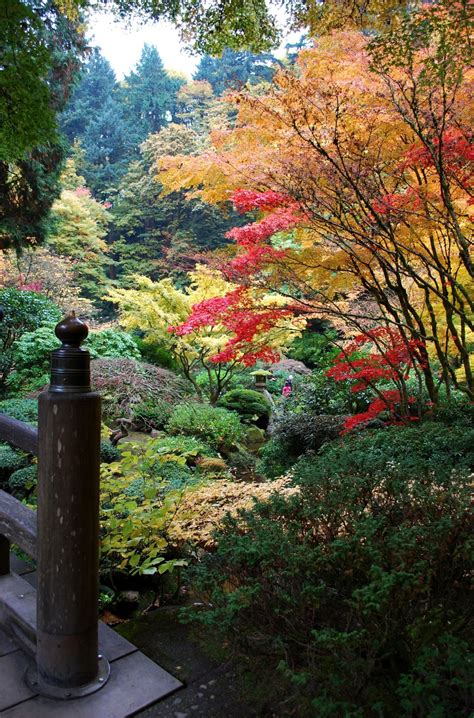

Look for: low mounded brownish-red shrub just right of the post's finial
[91,359,194,423]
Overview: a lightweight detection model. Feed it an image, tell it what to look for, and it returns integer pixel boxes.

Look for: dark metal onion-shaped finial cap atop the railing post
[49,312,91,394]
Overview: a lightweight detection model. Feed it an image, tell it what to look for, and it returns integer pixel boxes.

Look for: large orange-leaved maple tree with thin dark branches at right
[160,0,474,402]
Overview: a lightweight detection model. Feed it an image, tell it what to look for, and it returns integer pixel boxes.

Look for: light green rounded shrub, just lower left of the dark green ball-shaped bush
[167,404,244,452]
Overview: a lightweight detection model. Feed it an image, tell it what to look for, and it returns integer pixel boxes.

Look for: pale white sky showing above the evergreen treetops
[88,13,300,80]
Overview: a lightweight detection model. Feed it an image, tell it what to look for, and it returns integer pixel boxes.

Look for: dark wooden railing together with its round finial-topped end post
[0,314,109,699]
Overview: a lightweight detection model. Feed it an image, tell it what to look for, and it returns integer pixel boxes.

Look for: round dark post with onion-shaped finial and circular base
[29,313,109,698]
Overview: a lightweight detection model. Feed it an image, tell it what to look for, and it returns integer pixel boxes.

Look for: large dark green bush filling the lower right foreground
[185,423,474,718]
